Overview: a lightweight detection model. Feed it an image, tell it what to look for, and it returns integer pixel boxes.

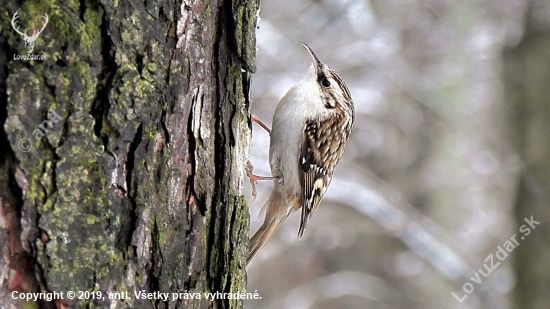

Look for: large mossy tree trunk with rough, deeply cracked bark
[0,0,259,308]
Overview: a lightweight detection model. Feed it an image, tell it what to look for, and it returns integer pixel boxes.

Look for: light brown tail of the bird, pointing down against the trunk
[246,189,287,265]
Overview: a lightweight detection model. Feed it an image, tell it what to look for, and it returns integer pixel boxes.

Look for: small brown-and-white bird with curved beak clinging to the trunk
[247,43,355,264]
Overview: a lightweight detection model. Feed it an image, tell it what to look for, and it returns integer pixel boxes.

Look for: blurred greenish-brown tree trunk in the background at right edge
[505,1,550,309]
